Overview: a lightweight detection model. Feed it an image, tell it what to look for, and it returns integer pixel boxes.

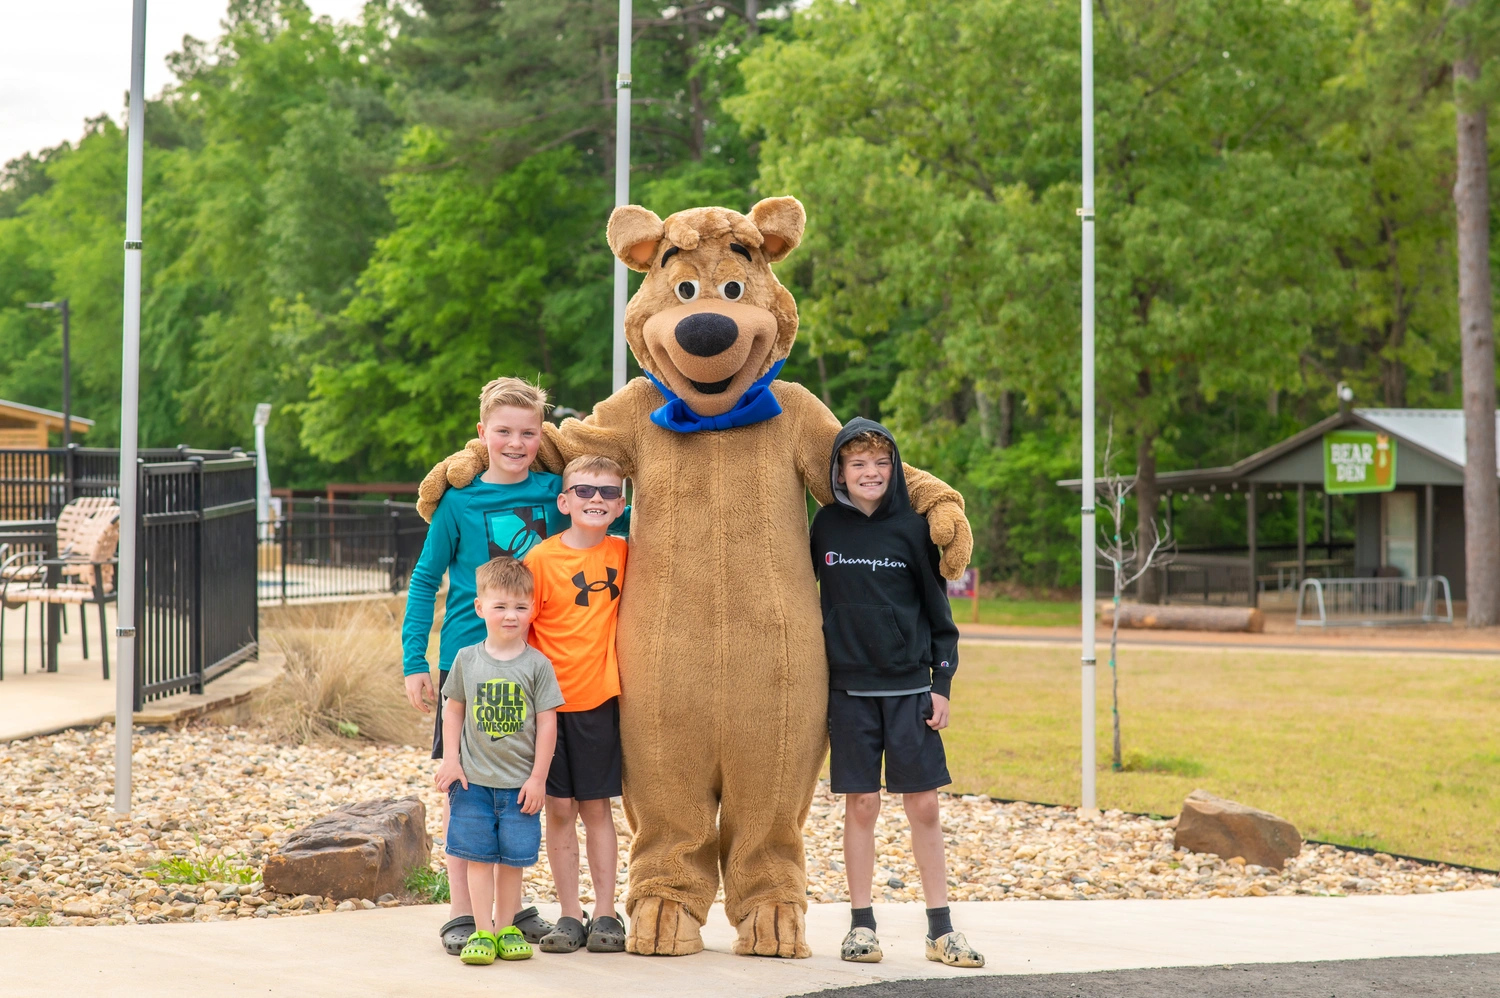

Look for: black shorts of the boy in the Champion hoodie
[828,690,953,794]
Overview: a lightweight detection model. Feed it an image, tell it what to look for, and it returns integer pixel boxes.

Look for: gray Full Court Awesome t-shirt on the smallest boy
[443,644,564,789]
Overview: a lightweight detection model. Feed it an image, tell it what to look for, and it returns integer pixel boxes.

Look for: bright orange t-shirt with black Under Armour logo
[525,534,627,711]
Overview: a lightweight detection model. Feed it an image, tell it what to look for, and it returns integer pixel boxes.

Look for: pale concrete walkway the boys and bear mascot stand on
[0,890,1500,998]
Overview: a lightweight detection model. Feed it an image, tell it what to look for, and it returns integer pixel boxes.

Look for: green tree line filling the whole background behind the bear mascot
[0,0,1482,590]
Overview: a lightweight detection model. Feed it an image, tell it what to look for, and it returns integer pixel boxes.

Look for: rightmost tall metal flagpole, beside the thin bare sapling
[1079,0,1098,810]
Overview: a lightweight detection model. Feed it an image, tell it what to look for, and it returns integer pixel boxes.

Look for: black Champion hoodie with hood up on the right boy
[813,417,959,696]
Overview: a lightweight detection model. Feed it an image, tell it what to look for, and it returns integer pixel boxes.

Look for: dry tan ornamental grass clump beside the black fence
[254,603,431,744]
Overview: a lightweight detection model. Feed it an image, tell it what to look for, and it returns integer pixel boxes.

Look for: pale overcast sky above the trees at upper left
[0,0,363,164]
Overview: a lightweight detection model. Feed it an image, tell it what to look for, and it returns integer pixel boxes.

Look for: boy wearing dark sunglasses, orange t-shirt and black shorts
[525,455,627,953]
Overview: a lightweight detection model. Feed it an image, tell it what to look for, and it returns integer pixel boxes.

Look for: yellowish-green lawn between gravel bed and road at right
[944,644,1500,869]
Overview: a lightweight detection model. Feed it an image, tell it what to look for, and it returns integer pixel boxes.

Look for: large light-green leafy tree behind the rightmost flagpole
[729,0,1347,588]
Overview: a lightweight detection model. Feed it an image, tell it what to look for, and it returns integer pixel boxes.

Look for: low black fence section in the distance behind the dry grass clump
[260,498,428,602]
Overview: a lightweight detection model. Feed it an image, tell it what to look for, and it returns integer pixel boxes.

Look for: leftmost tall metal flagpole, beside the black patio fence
[114,0,146,815]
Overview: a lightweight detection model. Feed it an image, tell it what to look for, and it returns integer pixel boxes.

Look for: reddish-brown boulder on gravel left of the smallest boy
[261,797,432,897]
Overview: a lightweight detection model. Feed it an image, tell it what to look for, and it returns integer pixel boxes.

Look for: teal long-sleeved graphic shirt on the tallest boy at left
[401,471,567,675]
